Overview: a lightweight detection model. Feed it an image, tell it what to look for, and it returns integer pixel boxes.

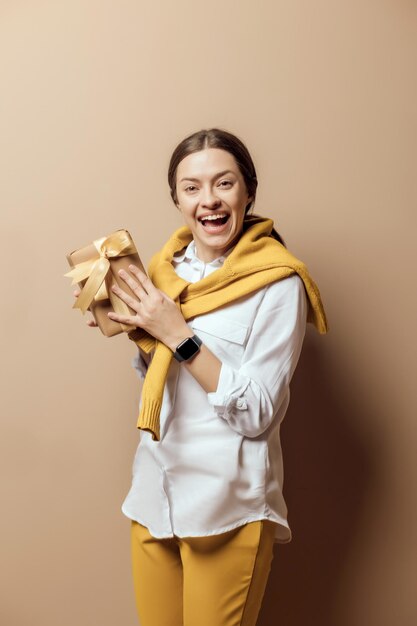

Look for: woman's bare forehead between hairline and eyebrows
[177,148,240,180]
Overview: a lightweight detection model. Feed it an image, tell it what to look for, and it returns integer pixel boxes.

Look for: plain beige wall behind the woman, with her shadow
[0,0,417,626]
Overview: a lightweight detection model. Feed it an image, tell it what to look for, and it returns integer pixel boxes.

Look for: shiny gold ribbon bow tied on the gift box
[64,230,137,329]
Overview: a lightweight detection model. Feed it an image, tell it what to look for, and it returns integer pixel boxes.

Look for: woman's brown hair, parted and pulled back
[168,128,285,245]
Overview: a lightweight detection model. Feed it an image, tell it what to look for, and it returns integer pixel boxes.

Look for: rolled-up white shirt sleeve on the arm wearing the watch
[207,274,308,437]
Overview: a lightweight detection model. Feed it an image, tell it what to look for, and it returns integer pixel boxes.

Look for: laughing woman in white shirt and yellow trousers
[77,128,327,626]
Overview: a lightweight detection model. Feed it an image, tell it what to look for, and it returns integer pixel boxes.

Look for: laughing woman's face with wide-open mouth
[177,148,251,263]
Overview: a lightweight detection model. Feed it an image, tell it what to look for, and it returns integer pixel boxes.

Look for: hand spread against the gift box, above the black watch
[108,265,193,351]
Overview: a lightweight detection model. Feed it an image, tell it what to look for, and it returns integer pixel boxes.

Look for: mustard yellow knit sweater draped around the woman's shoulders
[129,215,328,441]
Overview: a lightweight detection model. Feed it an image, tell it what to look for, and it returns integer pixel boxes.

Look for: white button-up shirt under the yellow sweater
[122,241,307,543]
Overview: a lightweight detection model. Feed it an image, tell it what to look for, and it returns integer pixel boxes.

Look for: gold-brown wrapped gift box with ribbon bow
[65,229,145,337]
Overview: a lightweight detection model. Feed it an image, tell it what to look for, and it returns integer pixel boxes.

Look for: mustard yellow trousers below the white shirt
[131,520,275,626]
